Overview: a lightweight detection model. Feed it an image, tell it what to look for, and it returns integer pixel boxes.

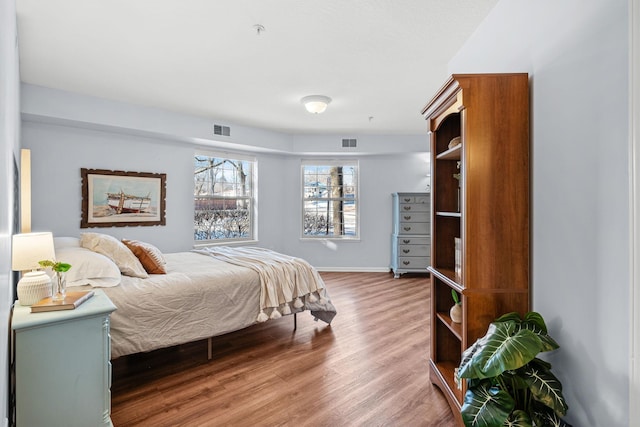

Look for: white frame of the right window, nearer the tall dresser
[299,159,361,242]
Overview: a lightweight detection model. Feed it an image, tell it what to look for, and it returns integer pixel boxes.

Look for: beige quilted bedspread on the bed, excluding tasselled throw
[69,252,336,358]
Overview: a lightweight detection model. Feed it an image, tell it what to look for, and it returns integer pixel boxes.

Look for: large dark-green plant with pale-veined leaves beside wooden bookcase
[458,312,570,427]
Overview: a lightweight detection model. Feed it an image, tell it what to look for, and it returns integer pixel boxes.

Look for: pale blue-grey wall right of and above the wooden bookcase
[449,0,633,426]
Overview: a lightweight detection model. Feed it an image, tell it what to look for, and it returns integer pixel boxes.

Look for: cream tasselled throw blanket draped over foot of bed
[194,247,326,322]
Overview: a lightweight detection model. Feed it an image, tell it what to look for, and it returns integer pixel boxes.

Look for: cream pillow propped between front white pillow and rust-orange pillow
[80,233,149,279]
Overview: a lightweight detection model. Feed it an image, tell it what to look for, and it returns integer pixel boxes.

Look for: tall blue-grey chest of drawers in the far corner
[391,193,431,279]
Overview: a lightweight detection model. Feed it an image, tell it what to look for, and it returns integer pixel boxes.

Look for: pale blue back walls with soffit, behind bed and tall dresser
[22,85,429,271]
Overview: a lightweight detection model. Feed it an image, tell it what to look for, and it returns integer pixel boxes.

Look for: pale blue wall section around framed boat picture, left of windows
[22,121,193,252]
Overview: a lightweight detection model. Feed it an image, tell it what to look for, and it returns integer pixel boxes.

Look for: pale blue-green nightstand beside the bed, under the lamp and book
[11,290,116,427]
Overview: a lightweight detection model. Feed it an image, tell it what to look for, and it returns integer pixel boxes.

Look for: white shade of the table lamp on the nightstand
[11,232,56,271]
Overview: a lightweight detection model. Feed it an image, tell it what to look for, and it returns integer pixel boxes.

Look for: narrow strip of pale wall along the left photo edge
[0,0,20,425]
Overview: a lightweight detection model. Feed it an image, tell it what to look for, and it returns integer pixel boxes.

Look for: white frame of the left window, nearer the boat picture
[192,150,258,248]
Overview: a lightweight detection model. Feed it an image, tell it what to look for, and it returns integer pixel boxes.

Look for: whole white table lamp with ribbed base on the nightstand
[11,232,55,305]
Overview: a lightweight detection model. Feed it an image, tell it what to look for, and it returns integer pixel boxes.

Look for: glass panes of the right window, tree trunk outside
[302,161,359,239]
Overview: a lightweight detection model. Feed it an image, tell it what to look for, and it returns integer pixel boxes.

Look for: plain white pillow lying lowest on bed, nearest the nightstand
[56,247,122,288]
